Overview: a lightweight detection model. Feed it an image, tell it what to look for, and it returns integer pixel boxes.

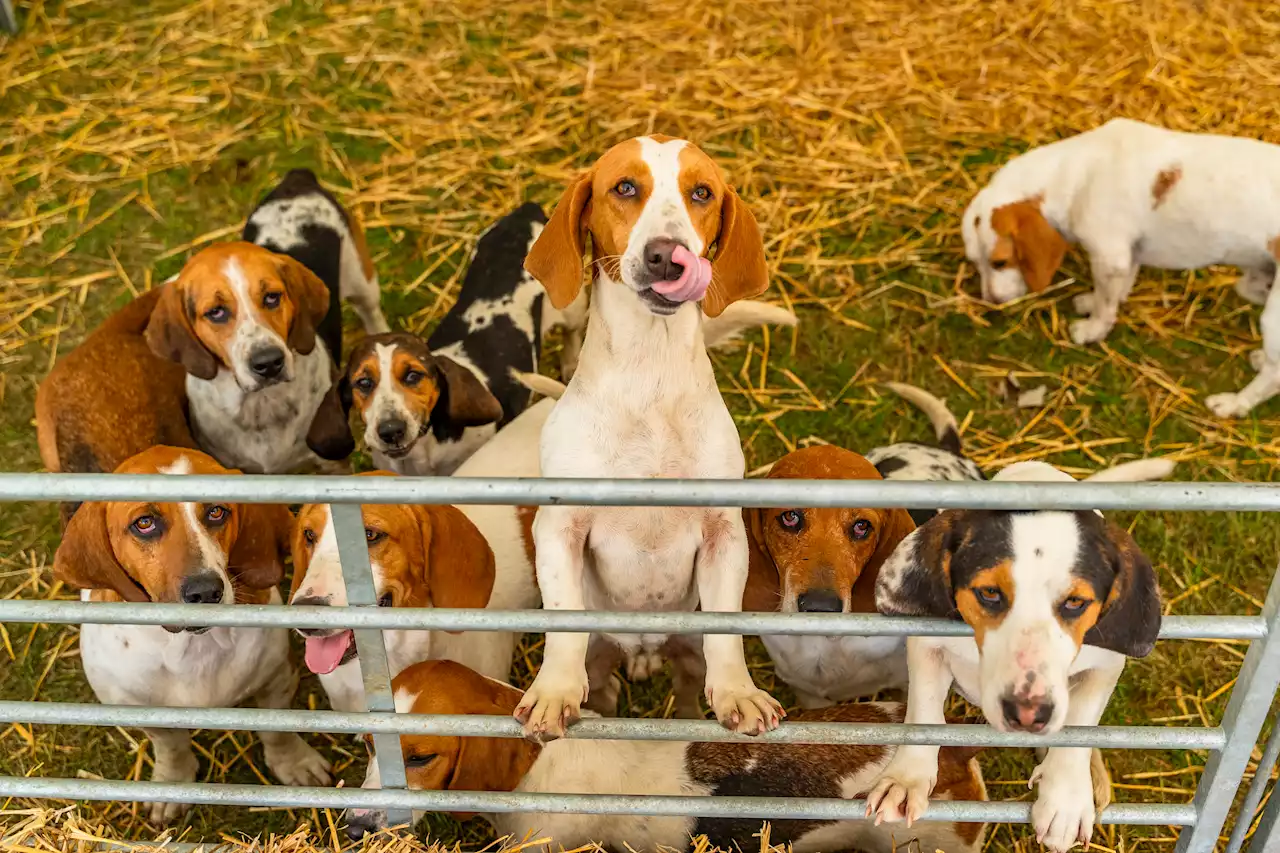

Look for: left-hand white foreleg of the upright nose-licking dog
[515,506,588,742]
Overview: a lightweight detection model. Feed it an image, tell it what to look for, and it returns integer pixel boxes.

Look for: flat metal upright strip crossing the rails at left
[329,503,413,826]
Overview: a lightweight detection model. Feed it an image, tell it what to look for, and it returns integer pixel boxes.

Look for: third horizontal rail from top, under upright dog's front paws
[0,702,1226,749]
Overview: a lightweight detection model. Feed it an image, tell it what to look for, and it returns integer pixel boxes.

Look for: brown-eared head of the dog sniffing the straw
[960,190,1066,302]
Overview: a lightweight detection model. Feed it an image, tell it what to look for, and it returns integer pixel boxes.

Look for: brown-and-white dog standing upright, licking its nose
[516,136,783,740]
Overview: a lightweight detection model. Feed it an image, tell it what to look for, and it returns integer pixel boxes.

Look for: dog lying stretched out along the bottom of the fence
[347,661,987,853]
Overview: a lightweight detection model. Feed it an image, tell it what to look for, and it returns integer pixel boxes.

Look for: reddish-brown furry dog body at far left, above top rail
[36,289,196,524]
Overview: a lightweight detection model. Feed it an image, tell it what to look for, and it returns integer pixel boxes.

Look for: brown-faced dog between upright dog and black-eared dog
[742,446,915,708]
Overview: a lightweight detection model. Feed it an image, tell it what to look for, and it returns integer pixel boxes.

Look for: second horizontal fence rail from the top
[0,599,1267,640]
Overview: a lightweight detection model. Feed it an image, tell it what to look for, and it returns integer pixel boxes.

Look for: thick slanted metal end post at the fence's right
[1174,560,1280,853]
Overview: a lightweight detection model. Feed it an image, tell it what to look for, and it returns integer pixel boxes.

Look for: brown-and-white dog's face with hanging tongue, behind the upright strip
[289,481,494,674]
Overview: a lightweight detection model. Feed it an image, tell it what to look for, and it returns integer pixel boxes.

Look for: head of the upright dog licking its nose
[525,136,768,316]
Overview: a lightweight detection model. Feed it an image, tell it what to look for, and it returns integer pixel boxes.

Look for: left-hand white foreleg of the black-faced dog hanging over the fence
[867,637,954,826]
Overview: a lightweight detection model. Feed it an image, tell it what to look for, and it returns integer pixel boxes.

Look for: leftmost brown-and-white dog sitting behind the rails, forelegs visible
[54,447,329,824]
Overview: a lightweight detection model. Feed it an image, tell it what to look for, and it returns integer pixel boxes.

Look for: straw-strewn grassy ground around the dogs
[0,0,1280,850]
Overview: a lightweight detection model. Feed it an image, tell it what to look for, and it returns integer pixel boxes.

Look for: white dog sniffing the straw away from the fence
[961,119,1280,418]
